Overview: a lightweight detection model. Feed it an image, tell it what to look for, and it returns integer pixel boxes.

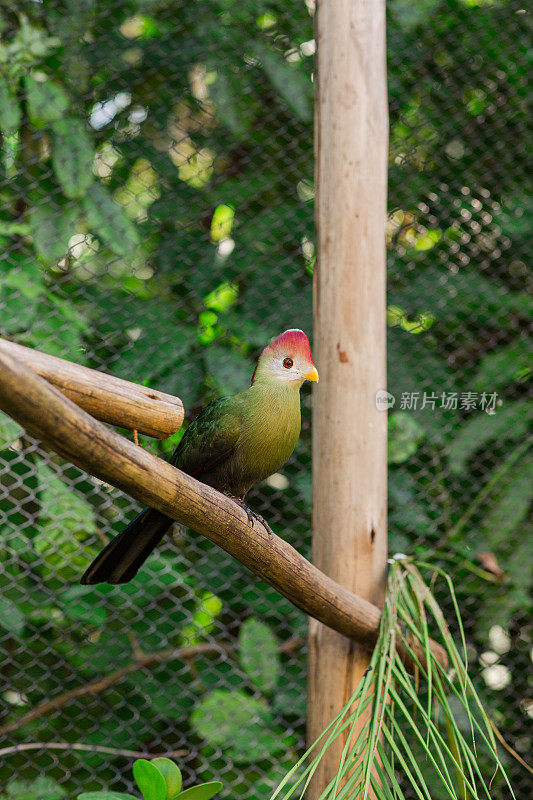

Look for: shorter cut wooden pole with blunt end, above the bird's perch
[0,339,183,439]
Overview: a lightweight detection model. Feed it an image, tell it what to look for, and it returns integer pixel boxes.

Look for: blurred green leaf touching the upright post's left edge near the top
[255,43,313,122]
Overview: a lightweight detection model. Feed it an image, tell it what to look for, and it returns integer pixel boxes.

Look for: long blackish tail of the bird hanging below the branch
[81,508,173,584]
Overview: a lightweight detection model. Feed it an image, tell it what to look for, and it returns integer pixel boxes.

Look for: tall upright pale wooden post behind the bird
[307,0,388,800]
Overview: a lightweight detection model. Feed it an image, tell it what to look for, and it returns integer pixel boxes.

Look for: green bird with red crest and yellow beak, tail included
[81,330,318,584]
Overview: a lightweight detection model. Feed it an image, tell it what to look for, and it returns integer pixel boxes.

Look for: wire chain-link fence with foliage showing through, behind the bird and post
[0,0,533,800]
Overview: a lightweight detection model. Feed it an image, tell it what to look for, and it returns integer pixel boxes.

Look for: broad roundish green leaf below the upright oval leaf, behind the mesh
[191,689,284,763]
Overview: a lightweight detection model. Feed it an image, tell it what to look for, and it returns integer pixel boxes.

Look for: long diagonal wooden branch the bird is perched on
[0,346,447,668]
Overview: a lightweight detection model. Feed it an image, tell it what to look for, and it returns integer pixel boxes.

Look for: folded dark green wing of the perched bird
[170,397,241,478]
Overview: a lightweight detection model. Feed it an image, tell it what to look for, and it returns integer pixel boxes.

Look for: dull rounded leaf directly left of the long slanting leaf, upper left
[29,199,78,262]
